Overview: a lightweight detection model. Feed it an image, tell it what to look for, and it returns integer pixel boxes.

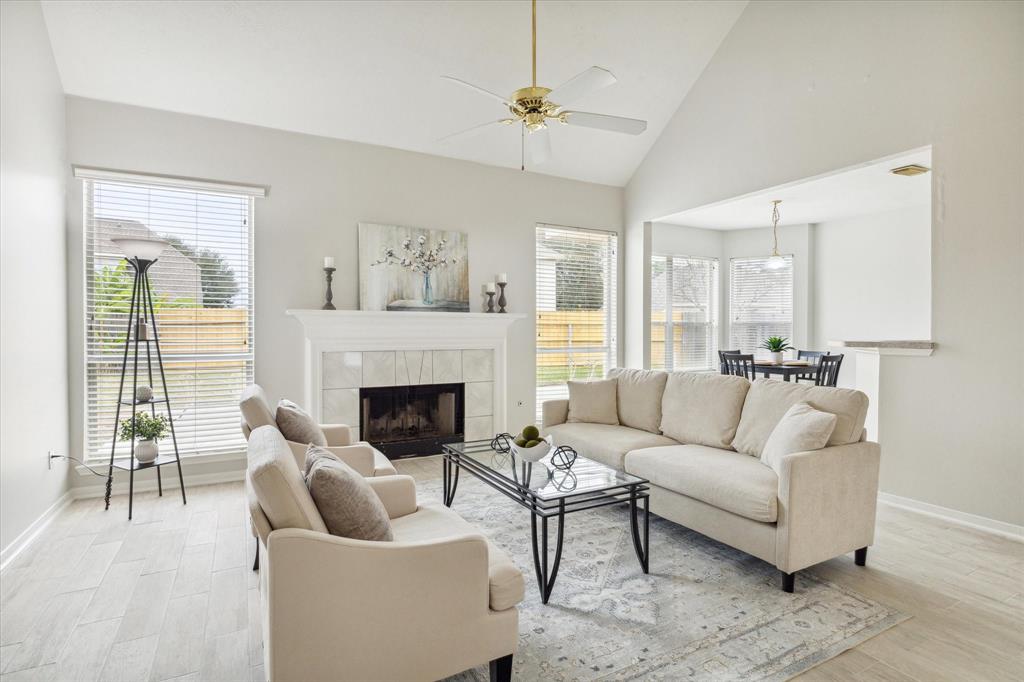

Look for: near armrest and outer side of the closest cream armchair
[264,528,503,680]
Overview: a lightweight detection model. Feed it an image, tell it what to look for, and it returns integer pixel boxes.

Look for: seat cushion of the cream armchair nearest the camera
[391,503,526,611]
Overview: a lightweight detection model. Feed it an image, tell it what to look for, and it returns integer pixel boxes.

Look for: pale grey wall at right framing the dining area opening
[626,1,1024,524]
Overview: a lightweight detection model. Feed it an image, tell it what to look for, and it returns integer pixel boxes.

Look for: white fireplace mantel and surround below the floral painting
[285,309,526,437]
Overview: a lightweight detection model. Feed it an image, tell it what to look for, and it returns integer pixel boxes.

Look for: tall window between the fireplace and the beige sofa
[537,225,618,422]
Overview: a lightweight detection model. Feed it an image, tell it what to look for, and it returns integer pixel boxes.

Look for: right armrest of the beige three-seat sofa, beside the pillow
[775,441,882,573]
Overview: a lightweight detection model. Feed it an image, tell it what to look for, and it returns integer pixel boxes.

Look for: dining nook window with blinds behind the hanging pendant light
[729,256,793,353]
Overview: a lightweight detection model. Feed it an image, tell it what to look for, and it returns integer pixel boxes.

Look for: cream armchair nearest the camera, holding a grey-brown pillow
[246,426,524,682]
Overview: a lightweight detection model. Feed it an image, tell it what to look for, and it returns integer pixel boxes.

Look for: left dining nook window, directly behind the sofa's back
[650,256,718,372]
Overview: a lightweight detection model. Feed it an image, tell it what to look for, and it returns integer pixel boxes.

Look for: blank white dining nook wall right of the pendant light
[811,205,932,387]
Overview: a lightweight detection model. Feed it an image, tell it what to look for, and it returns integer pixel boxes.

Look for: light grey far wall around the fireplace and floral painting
[68,97,623,483]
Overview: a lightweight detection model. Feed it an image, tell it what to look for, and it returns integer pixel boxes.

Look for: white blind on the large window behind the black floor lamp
[83,178,254,460]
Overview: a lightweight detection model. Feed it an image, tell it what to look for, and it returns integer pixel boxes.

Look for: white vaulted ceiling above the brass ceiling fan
[43,0,746,185]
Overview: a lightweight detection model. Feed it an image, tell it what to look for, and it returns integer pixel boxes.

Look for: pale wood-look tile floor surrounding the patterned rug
[0,458,1024,682]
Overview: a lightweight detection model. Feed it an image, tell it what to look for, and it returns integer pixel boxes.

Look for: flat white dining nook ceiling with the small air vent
[657,147,932,229]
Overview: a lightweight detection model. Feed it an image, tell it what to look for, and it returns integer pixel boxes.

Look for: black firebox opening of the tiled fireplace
[359,384,465,459]
